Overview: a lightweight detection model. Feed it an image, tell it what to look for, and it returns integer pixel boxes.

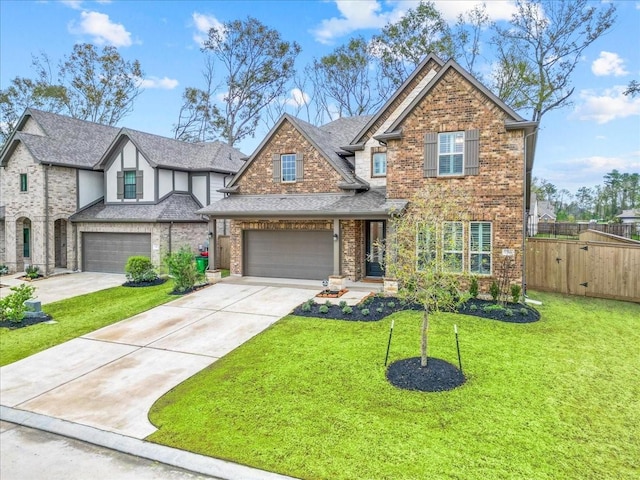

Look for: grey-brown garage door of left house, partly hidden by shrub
[82,232,151,273]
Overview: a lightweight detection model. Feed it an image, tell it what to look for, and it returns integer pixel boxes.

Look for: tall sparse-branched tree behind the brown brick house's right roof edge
[493,0,616,122]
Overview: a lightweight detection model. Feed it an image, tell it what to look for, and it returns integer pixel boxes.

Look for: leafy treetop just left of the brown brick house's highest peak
[372,2,455,88]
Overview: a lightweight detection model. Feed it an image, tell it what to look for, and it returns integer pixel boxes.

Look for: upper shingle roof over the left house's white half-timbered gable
[95,128,244,173]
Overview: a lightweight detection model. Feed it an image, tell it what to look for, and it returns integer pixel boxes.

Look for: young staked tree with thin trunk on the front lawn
[380,187,466,367]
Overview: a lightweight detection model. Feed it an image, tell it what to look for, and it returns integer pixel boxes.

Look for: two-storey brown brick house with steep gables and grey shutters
[200,55,537,288]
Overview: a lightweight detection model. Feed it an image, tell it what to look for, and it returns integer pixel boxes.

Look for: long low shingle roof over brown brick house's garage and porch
[198,188,408,218]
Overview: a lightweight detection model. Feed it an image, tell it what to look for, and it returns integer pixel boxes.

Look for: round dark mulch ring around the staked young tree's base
[387,357,466,392]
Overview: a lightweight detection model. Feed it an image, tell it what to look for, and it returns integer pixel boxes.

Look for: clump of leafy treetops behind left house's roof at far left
[0,43,143,141]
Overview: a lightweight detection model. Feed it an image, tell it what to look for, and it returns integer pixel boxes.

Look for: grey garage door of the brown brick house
[244,230,333,280]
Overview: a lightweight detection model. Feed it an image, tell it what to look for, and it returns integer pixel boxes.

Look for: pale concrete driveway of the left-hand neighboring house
[0,272,126,305]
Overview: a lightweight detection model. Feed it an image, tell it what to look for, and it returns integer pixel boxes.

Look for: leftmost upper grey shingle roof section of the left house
[0,108,119,168]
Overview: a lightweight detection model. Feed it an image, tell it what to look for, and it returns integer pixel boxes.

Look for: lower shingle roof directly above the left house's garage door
[69,193,203,222]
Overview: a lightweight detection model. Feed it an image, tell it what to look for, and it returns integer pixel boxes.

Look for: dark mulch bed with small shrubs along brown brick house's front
[293,295,540,323]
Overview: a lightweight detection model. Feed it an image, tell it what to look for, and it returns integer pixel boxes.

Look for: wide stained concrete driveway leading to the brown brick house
[0,282,320,439]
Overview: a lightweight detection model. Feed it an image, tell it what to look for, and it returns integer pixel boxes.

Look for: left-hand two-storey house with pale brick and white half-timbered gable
[0,109,243,274]
